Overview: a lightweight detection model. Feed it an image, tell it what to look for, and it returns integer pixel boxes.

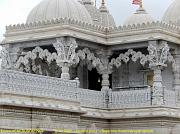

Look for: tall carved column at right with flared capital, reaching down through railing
[148,41,170,105]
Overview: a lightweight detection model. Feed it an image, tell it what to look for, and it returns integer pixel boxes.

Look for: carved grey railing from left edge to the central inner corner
[0,70,105,108]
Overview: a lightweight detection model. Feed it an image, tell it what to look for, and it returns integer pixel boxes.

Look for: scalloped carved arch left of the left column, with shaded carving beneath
[15,47,57,76]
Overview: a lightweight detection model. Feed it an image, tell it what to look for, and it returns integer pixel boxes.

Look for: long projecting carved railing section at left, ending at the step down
[0,70,77,101]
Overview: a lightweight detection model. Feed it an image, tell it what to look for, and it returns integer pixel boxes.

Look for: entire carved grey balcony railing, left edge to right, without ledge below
[0,70,176,109]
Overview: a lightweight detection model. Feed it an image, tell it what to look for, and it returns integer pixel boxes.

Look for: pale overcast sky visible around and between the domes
[0,0,173,41]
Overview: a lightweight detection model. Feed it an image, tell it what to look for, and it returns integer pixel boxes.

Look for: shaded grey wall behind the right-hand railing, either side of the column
[112,61,173,90]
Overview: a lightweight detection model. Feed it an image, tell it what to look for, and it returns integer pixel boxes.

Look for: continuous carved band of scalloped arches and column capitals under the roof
[1,38,175,76]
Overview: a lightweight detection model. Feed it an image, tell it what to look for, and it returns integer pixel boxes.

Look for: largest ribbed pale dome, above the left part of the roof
[26,0,93,24]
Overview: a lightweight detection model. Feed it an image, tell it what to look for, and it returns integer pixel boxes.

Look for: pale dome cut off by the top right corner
[162,0,180,24]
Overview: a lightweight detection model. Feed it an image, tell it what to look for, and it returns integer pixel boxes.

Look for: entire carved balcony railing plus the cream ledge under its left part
[0,70,178,112]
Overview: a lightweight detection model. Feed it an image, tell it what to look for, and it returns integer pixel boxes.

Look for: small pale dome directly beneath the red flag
[124,7,154,25]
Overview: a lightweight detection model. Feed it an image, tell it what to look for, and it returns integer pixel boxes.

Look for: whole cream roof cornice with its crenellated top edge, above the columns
[1,18,180,45]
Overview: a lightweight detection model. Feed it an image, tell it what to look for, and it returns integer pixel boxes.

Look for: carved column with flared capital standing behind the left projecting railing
[53,38,78,80]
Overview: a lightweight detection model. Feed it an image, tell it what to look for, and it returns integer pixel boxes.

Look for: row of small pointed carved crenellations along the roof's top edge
[6,18,180,34]
